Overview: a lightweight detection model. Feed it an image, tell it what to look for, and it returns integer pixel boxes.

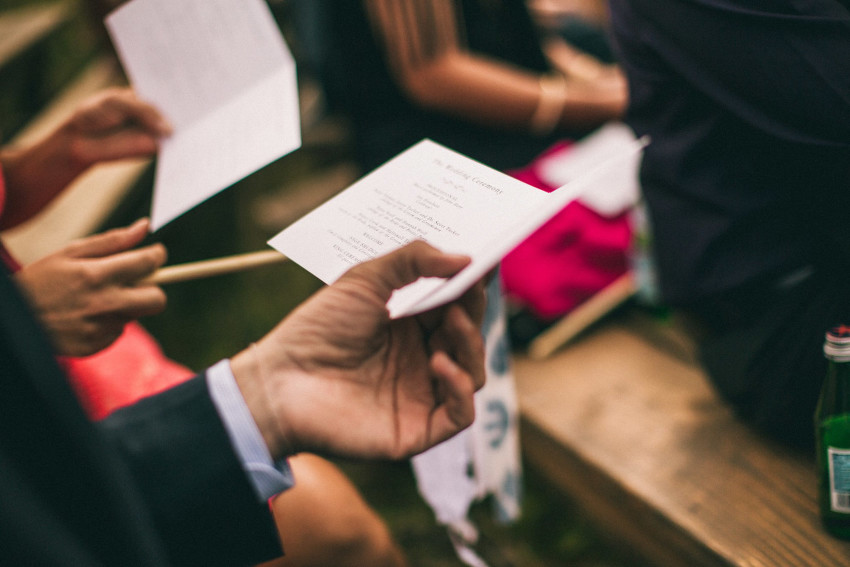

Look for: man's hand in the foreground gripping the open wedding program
[231,242,484,464]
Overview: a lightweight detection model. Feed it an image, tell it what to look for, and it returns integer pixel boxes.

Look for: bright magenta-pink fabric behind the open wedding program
[500,143,632,320]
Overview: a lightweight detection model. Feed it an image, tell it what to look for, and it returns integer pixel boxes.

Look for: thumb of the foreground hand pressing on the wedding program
[340,240,470,301]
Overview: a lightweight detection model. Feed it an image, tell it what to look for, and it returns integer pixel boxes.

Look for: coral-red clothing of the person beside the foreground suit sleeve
[0,164,193,419]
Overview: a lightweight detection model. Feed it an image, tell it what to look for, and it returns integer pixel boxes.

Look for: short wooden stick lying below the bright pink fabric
[528,272,637,360]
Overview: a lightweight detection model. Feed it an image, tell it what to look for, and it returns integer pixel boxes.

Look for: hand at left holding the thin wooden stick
[14,219,165,356]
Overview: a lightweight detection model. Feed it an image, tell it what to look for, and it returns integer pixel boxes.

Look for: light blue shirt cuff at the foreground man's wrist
[206,359,295,502]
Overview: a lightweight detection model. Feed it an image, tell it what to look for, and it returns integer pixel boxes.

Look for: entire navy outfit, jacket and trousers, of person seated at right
[611,0,850,448]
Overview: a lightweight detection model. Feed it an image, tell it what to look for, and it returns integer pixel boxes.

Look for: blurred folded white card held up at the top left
[106,0,301,230]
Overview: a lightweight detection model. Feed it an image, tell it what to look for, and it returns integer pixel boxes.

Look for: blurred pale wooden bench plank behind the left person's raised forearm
[2,57,151,263]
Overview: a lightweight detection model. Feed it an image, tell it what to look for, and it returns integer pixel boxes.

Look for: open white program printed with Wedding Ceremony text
[269,136,641,317]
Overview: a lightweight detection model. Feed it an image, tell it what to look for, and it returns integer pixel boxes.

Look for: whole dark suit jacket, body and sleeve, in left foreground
[0,267,281,567]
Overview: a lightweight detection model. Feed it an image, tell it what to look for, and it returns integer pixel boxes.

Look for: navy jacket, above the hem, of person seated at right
[612,0,850,305]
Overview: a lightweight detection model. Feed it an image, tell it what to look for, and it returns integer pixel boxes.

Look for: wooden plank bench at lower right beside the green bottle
[514,303,850,567]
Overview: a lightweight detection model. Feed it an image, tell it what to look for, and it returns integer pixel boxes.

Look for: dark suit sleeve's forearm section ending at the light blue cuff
[96,375,281,566]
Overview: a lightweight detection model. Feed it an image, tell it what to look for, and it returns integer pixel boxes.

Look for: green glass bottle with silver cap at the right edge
[815,325,850,539]
